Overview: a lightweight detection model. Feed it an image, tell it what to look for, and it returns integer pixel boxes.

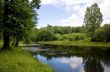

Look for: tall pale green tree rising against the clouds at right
[84,3,103,32]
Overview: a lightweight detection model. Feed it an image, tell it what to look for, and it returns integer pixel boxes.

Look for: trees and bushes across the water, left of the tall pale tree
[36,25,86,41]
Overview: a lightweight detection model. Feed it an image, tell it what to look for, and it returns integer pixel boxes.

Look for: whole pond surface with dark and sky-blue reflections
[30,45,110,72]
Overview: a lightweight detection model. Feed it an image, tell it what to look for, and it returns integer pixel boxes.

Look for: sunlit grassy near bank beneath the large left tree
[0,48,53,72]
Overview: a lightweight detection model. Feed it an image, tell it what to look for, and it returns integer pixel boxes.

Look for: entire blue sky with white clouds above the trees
[38,0,110,27]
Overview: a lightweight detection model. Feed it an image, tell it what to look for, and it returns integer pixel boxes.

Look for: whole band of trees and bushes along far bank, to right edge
[35,24,110,42]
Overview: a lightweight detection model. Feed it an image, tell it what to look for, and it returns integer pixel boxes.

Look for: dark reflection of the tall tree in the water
[83,50,104,72]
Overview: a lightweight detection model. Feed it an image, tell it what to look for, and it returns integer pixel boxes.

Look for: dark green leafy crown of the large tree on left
[1,0,34,33]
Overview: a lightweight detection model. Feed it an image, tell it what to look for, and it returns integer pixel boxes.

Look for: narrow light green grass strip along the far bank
[38,41,110,47]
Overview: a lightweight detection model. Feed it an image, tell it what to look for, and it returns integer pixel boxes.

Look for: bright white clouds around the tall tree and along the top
[41,0,110,26]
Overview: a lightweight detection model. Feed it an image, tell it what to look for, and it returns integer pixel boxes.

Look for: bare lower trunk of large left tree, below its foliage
[3,32,10,49]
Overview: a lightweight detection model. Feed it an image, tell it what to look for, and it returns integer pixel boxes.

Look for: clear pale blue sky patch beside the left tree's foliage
[38,5,71,27]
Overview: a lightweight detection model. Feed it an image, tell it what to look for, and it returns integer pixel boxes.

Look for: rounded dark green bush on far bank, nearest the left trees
[36,30,55,41]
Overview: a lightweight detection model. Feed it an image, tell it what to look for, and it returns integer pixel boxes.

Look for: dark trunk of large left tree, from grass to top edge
[2,0,10,49]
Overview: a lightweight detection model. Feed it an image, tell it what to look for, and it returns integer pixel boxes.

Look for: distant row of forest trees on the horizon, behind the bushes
[39,24,85,34]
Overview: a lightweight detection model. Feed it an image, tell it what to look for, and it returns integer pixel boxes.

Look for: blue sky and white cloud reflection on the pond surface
[37,55,84,72]
